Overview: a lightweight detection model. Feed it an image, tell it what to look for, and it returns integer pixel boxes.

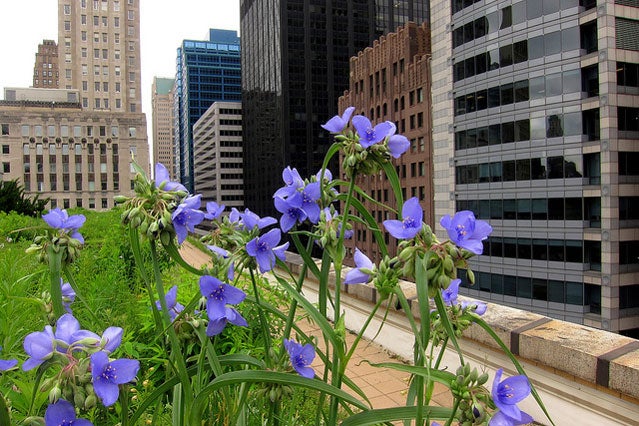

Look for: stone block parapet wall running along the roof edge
[287,253,639,406]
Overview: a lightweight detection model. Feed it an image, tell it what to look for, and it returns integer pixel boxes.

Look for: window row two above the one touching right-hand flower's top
[455,109,600,150]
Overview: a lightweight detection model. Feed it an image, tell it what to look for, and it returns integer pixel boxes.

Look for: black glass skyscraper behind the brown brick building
[240,0,428,215]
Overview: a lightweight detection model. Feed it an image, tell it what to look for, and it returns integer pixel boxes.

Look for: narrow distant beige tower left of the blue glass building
[151,77,175,175]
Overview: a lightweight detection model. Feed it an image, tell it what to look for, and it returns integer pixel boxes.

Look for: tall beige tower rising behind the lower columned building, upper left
[58,0,142,113]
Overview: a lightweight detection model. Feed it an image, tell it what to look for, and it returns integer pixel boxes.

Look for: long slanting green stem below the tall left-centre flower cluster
[149,240,193,424]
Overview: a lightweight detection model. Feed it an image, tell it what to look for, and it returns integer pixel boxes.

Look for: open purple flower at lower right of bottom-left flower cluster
[91,352,140,407]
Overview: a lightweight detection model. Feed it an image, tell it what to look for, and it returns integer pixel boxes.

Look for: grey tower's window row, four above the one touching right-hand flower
[453,21,597,82]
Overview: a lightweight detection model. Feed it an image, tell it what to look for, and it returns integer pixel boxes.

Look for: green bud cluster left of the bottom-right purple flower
[450,364,490,426]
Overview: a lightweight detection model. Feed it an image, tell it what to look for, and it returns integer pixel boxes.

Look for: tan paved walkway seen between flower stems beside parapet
[180,241,453,408]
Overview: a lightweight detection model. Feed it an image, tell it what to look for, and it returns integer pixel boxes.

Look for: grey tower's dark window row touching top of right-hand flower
[457,197,600,222]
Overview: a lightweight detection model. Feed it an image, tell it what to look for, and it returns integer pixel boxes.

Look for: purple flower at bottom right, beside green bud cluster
[489,368,532,426]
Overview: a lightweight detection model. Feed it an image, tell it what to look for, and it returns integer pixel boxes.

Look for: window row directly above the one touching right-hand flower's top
[455,155,583,185]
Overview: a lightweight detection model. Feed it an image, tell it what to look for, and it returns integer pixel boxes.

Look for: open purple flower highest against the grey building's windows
[439,210,493,254]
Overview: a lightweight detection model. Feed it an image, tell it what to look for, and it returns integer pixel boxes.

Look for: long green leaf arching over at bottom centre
[190,370,368,424]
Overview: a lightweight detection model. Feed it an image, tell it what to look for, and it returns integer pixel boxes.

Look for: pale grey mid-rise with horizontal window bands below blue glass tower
[193,102,244,211]
